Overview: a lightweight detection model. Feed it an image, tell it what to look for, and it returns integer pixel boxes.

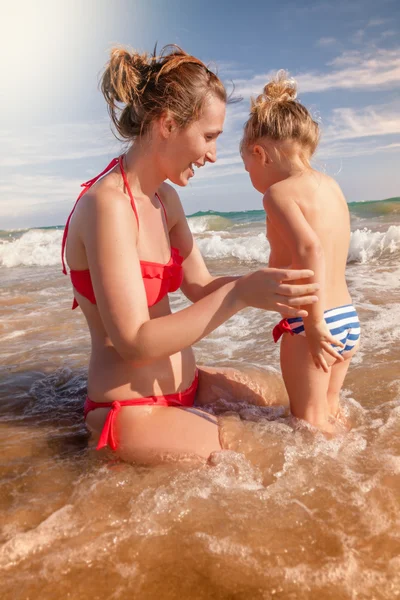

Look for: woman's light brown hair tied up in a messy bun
[100,45,227,140]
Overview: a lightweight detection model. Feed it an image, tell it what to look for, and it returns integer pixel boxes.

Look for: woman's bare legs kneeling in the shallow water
[86,360,287,464]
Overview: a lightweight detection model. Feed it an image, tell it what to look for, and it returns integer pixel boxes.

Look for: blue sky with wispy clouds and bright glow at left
[0,0,400,229]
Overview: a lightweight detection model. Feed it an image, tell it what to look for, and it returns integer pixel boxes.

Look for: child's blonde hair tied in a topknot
[241,70,320,160]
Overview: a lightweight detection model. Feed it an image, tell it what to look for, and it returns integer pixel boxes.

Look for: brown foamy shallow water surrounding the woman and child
[0,205,400,600]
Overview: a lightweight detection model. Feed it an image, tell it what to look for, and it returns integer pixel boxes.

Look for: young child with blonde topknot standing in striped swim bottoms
[241,71,360,432]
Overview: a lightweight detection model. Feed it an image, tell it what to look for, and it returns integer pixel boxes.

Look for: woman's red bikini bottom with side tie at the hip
[83,369,199,450]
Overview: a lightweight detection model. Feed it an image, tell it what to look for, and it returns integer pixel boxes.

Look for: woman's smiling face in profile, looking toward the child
[164,96,226,186]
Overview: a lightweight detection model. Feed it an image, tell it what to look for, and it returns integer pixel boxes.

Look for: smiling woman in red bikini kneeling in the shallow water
[63,47,317,462]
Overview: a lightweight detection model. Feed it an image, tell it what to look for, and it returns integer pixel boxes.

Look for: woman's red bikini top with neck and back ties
[61,156,183,310]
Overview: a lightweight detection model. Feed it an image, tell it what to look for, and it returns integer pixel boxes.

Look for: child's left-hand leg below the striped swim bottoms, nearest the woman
[281,333,335,431]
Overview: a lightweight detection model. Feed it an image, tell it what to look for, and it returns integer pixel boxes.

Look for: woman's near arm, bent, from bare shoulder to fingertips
[81,191,317,364]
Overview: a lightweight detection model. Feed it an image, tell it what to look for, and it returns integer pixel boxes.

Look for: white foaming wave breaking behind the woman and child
[0,223,400,268]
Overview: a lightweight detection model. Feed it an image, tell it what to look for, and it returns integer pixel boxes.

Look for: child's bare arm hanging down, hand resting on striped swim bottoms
[264,188,343,371]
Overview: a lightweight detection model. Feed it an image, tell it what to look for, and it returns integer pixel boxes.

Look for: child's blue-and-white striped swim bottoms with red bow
[287,304,360,354]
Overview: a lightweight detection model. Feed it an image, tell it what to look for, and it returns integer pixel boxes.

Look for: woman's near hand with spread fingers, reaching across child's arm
[237,268,319,317]
